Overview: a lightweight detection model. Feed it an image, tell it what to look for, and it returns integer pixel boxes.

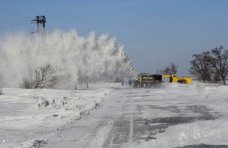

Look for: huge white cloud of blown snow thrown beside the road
[0,30,136,88]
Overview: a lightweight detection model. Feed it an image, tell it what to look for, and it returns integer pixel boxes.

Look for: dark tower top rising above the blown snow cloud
[32,16,46,35]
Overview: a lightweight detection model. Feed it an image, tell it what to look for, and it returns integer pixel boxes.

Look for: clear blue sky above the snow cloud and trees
[0,0,228,75]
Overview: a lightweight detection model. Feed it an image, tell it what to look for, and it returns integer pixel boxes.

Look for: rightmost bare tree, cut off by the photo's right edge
[210,46,228,85]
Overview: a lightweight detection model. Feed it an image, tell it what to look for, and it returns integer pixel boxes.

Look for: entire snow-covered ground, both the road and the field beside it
[0,83,228,148]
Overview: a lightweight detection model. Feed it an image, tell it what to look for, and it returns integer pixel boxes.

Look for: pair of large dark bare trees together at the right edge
[189,46,228,85]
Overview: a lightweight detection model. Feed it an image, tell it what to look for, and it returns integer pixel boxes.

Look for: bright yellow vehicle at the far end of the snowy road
[162,74,192,84]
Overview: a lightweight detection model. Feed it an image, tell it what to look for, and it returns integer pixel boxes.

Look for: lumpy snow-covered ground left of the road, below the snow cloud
[0,83,120,147]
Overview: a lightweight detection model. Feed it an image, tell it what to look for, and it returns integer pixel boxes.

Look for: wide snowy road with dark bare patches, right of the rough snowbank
[44,85,228,148]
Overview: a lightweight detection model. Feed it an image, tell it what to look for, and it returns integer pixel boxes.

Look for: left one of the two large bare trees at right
[189,52,212,82]
